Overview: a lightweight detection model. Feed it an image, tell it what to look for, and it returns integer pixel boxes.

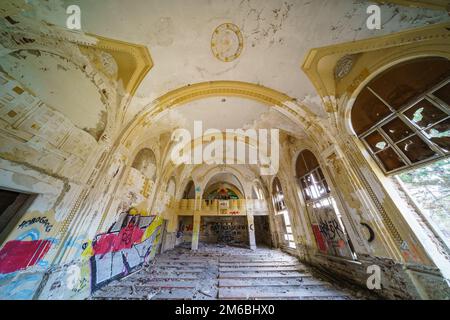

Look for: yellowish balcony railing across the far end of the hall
[169,199,268,215]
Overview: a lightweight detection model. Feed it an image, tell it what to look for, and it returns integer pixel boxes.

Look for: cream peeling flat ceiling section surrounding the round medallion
[60,0,450,120]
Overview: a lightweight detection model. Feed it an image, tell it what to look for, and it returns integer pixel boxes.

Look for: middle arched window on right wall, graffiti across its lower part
[295,150,355,258]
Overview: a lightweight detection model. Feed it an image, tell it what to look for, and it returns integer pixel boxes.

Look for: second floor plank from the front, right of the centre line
[219,277,329,287]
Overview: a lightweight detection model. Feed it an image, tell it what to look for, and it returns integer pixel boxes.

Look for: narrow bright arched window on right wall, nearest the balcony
[272,177,295,248]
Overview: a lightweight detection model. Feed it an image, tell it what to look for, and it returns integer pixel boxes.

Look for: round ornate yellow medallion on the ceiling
[211,23,244,62]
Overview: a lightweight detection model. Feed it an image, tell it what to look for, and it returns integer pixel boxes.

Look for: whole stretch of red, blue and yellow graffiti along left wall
[0,209,163,299]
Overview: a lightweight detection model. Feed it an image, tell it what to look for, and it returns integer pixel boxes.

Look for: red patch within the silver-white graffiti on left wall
[93,224,144,255]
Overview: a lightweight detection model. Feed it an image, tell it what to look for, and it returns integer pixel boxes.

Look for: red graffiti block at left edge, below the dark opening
[0,240,52,273]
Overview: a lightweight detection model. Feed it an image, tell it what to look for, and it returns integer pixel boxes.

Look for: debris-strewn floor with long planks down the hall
[92,245,370,300]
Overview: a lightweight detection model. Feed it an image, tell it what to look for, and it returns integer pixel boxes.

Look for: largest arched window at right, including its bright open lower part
[351,57,450,243]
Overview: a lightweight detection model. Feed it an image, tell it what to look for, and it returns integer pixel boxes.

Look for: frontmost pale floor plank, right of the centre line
[219,287,345,299]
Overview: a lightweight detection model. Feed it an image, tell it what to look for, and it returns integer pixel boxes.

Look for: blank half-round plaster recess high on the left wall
[0,50,106,139]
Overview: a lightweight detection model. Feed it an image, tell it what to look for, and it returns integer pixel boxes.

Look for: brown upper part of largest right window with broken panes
[352,58,450,174]
